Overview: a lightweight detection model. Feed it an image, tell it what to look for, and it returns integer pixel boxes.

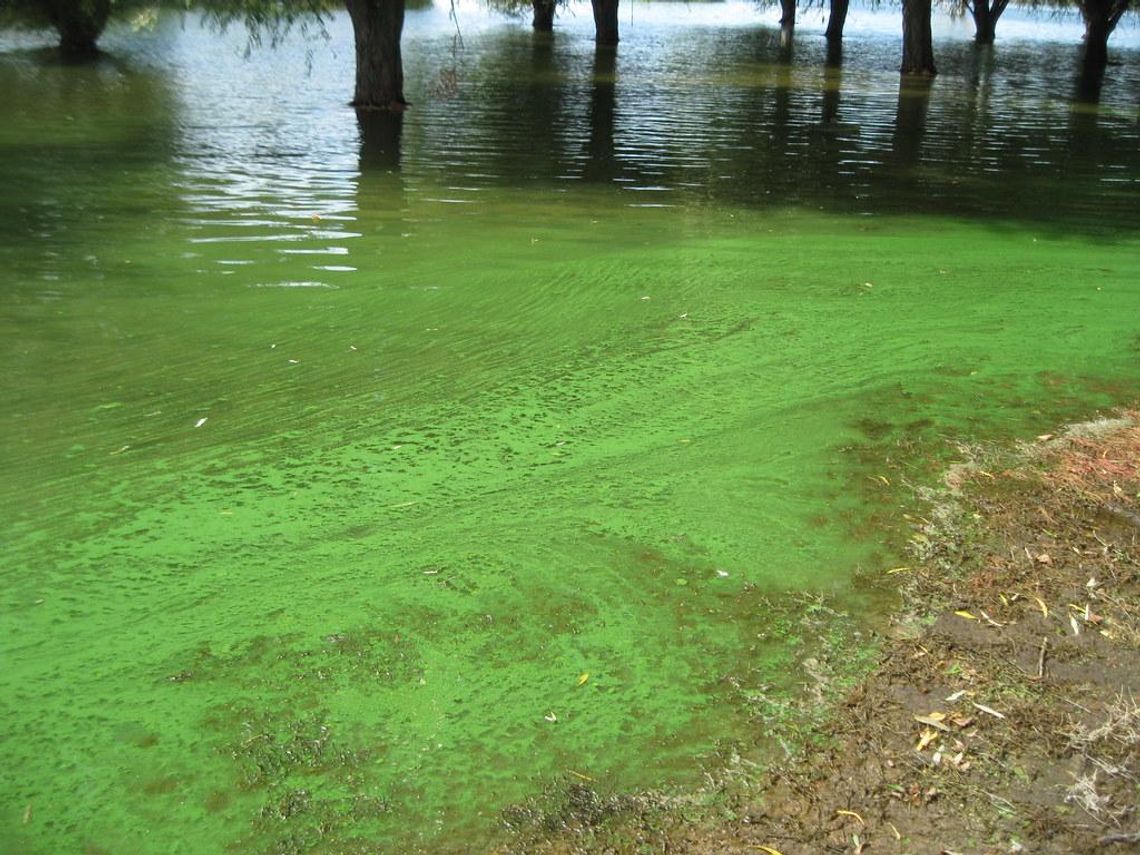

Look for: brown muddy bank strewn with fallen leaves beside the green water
[506,412,1140,855]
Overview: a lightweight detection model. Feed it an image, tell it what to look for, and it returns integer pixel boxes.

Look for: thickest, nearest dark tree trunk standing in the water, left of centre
[344,0,408,111]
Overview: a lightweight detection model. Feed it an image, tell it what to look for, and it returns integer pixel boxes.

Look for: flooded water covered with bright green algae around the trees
[0,3,1140,853]
